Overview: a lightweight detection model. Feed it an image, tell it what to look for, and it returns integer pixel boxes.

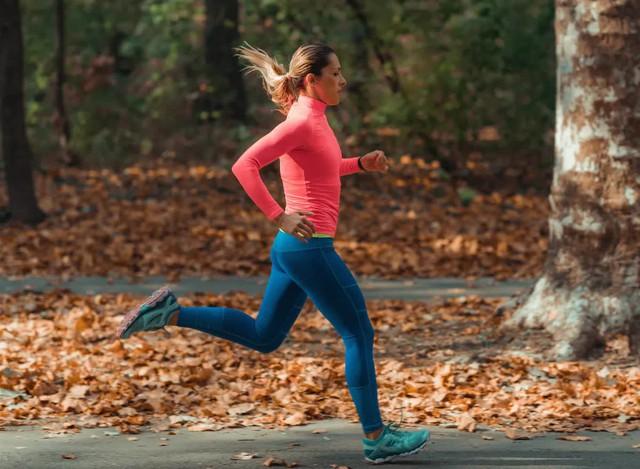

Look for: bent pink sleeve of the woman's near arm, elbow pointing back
[231,120,305,220]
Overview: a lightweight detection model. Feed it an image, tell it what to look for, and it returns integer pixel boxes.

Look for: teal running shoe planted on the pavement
[362,424,429,464]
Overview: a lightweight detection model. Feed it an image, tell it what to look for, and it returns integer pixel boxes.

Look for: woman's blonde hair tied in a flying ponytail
[236,42,335,115]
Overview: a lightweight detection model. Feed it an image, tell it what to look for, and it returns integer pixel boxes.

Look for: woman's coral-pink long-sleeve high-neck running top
[231,95,360,237]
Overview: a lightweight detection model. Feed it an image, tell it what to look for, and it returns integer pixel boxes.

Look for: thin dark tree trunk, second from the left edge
[55,0,80,166]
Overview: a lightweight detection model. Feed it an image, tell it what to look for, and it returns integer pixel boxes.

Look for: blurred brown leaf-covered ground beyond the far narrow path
[0,156,548,279]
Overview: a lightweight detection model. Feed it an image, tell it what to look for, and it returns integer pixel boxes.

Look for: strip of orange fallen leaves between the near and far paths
[0,291,640,437]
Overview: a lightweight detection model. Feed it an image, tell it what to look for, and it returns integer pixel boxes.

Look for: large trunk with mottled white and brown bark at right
[506,0,640,359]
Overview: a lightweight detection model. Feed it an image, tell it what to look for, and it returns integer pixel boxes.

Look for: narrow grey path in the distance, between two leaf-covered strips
[0,277,533,300]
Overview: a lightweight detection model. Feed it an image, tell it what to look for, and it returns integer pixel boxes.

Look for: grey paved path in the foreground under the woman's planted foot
[0,420,640,469]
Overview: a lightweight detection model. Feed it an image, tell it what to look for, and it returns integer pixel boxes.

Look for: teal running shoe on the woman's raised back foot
[117,287,180,339]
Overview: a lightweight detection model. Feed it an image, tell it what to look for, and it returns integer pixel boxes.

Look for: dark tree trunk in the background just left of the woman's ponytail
[204,0,246,119]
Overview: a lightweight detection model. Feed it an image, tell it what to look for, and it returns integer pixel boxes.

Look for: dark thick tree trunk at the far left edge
[0,0,44,224]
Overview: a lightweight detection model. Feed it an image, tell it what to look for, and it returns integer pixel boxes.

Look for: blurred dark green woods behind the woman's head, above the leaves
[21,0,555,186]
